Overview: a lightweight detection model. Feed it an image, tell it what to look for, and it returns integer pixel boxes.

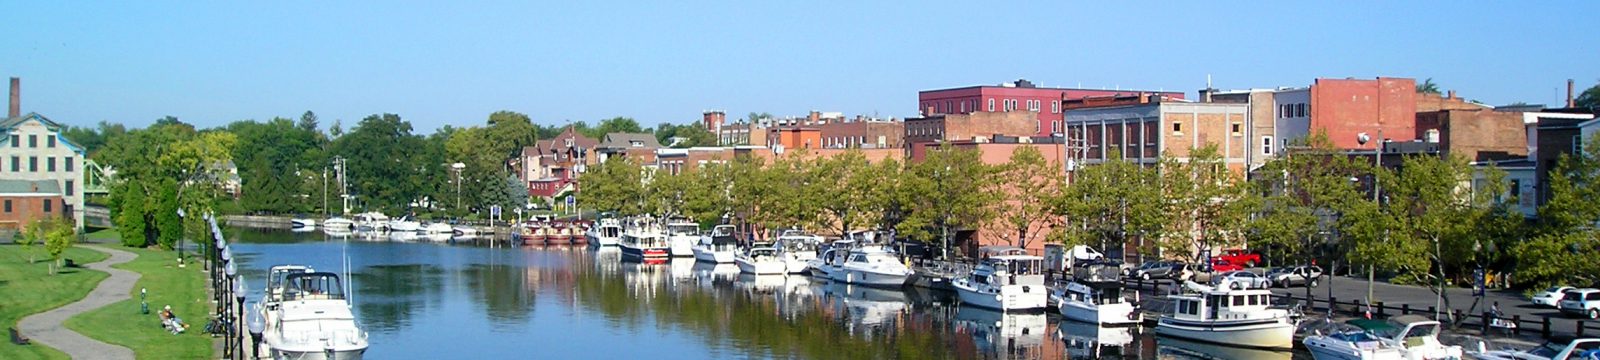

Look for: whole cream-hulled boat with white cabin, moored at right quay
[1155,282,1294,349]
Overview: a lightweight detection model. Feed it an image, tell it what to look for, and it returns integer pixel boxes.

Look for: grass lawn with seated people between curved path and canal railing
[67,245,214,358]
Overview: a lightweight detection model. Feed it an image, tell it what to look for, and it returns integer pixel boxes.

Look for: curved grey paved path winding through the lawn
[18,245,139,360]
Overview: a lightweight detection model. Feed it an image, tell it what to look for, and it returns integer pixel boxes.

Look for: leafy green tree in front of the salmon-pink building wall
[990,146,1064,248]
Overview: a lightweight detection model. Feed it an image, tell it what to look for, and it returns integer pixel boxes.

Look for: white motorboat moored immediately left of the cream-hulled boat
[1056,262,1144,326]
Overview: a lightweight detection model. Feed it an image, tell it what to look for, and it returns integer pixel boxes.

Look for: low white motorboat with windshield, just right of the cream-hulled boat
[1324,315,1462,360]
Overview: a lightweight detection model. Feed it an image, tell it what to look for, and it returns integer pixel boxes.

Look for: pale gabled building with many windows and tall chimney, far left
[0,77,86,224]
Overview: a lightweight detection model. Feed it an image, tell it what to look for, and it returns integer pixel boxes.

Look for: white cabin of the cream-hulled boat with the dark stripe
[1170,283,1285,322]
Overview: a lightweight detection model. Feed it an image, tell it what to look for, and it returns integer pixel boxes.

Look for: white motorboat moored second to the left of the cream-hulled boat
[947,246,1050,312]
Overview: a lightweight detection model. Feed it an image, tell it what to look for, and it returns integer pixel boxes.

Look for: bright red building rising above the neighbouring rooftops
[917,80,1184,136]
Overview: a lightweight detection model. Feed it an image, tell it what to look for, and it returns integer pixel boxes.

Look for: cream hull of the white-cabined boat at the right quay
[1155,317,1294,349]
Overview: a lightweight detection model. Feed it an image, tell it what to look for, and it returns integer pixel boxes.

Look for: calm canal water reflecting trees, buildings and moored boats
[227,229,1310,360]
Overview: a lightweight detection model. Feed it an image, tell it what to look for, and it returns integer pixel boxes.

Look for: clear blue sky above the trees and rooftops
[0,2,1600,133]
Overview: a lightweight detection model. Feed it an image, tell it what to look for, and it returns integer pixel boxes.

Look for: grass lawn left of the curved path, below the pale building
[0,245,107,360]
